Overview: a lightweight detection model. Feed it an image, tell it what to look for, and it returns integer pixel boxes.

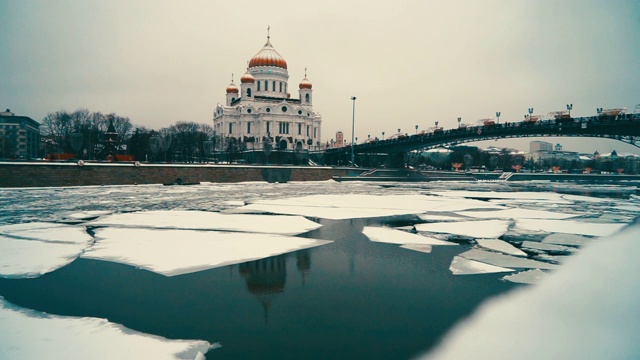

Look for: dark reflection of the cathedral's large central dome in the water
[240,255,287,324]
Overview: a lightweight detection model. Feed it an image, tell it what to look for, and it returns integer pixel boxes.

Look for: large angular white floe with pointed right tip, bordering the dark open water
[82,228,331,276]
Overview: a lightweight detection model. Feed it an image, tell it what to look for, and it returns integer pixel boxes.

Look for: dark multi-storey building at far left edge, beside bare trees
[0,109,40,159]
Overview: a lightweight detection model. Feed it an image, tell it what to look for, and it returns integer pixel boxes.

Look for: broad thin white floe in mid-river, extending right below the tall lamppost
[228,194,501,220]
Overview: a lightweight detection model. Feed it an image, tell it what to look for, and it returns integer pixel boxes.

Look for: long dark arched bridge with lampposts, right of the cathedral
[325,113,640,167]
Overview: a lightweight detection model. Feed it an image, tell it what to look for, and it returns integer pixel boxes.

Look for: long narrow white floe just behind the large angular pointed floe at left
[87,210,322,235]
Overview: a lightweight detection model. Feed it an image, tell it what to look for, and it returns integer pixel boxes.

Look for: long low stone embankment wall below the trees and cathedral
[0,162,347,187]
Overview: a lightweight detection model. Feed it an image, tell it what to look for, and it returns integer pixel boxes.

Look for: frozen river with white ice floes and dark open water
[0,181,640,359]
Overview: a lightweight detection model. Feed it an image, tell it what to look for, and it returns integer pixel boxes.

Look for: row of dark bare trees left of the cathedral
[40,109,216,162]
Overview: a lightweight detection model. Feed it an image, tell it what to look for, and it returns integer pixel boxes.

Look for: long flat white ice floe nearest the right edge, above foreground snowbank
[516,219,626,236]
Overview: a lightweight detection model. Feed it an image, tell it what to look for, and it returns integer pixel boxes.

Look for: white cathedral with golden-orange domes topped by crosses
[213,36,322,150]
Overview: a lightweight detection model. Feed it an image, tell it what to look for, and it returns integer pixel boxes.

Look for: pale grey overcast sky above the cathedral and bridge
[0,0,640,153]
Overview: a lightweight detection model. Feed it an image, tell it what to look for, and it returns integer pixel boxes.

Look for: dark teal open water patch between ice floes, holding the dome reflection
[0,217,517,359]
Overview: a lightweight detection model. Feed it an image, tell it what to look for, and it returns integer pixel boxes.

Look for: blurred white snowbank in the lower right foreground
[426,223,640,360]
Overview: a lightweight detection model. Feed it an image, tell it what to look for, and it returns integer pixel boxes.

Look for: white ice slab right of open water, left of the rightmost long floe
[415,220,510,238]
